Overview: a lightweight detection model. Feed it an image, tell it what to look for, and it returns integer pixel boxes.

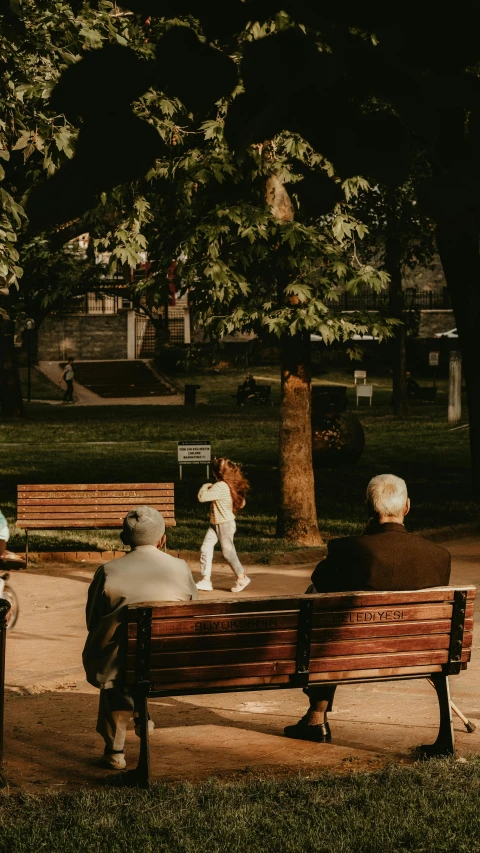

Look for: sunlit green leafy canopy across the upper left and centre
[2,0,396,342]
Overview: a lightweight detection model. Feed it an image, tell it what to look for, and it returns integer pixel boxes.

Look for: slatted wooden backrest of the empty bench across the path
[17,483,175,530]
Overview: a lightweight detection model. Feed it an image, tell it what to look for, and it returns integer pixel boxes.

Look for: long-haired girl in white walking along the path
[197,457,250,592]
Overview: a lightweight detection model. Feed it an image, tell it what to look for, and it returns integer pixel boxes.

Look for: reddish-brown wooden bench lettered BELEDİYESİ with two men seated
[123,586,475,787]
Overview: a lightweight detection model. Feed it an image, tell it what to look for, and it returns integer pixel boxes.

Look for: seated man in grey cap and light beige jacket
[83,506,198,770]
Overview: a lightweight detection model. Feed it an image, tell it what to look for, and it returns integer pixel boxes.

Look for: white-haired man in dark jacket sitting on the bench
[284,474,450,743]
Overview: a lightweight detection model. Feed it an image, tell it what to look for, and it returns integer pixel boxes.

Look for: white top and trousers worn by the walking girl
[198,480,245,580]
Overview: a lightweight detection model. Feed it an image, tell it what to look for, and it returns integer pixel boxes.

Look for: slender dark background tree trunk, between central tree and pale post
[385,216,408,418]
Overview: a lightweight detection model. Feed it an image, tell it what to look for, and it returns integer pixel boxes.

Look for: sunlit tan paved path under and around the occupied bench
[5,538,480,791]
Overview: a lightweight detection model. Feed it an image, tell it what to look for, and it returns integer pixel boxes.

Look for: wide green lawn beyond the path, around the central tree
[0,368,478,559]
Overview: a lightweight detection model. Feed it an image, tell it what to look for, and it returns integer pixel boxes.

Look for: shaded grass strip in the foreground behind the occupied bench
[0,759,480,853]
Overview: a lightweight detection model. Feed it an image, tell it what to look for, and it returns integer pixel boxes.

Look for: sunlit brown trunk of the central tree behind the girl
[277,332,322,545]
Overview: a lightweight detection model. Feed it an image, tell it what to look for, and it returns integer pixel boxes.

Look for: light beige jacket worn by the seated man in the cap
[83,545,198,688]
